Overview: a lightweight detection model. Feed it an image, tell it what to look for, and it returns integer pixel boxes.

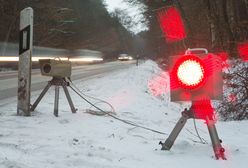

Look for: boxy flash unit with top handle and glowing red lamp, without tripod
[169,48,223,101]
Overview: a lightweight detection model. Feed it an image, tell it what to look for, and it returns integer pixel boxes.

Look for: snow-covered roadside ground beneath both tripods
[0,61,248,168]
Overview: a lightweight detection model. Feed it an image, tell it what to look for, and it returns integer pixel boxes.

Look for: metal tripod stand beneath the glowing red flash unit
[159,102,226,160]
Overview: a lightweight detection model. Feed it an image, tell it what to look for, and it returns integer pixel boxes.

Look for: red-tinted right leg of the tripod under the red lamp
[206,118,226,160]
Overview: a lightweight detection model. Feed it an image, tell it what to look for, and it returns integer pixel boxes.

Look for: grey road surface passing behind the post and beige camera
[0,61,135,100]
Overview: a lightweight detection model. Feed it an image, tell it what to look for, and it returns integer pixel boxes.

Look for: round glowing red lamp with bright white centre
[173,55,206,89]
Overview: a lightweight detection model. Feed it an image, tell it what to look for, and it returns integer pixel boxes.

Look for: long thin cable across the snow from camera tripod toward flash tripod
[69,86,168,135]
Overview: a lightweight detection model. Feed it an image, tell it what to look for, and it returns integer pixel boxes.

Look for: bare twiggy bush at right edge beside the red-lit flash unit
[217,60,248,121]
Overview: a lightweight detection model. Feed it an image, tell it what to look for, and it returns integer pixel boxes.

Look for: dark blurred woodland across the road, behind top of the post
[0,0,136,56]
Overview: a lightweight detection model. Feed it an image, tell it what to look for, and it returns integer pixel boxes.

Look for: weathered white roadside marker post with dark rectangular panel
[17,7,33,116]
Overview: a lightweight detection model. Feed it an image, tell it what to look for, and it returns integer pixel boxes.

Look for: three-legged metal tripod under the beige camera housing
[30,77,77,117]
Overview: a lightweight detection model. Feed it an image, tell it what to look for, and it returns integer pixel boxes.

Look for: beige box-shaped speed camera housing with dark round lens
[39,59,71,78]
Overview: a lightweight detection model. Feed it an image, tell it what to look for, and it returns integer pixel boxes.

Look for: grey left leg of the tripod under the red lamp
[159,115,188,150]
